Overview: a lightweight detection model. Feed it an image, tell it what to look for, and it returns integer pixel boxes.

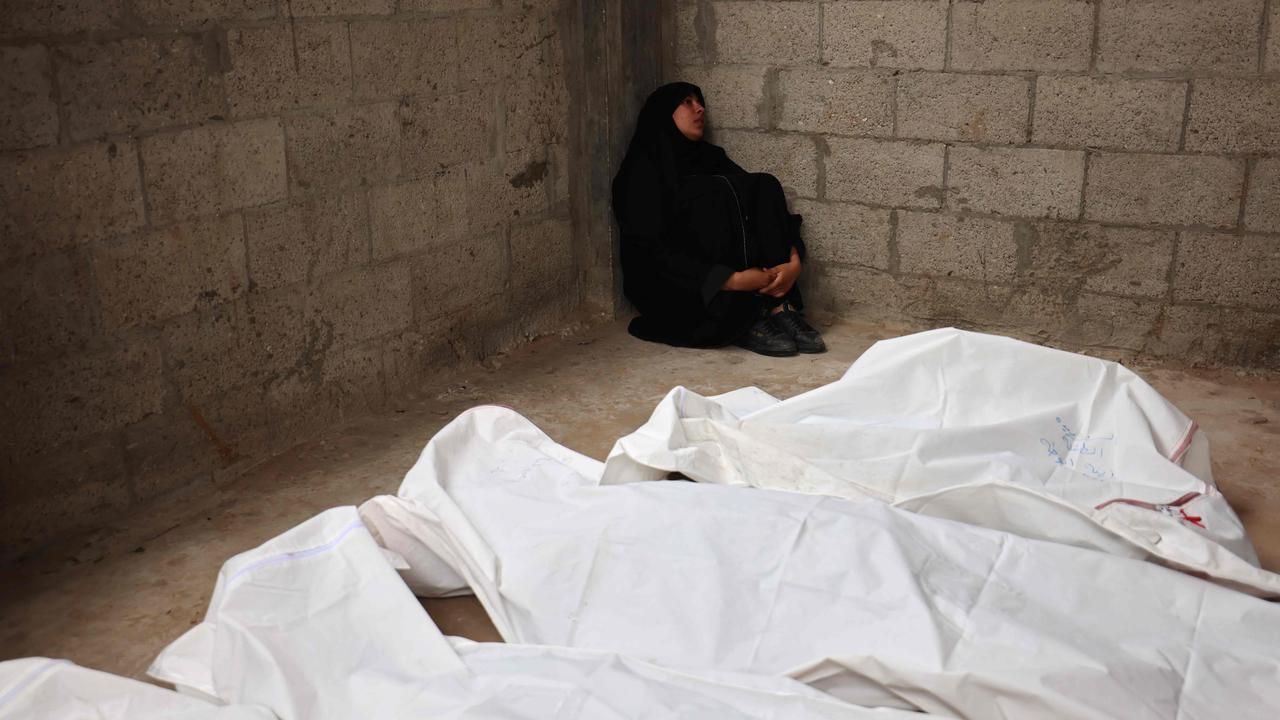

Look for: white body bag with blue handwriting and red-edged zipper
[602,329,1280,597]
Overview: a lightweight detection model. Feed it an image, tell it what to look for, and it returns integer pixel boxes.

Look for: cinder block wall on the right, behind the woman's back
[667,0,1280,368]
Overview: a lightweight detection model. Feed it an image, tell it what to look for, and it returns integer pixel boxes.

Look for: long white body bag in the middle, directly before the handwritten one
[362,407,1280,720]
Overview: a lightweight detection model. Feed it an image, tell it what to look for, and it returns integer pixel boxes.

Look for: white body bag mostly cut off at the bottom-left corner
[0,657,275,720]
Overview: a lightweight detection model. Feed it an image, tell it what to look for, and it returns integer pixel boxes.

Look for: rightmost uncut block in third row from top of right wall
[1084,152,1244,227]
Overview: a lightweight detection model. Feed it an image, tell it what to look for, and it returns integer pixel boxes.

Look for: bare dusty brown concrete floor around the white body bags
[0,322,1280,678]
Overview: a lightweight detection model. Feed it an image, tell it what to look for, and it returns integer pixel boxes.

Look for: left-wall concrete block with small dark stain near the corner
[466,150,550,232]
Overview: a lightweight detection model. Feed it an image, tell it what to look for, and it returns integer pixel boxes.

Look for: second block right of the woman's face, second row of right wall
[897,73,1030,145]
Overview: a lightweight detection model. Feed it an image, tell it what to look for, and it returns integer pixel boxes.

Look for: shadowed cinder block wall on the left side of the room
[0,0,579,555]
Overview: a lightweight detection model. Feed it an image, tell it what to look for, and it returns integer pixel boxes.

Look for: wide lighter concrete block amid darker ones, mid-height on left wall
[142,118,289,224]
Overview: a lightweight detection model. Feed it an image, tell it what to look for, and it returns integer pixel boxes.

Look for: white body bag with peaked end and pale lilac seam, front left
[151,507,931,720]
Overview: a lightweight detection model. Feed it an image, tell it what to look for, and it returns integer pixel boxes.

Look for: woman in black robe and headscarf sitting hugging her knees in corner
[613,82,827,357]
